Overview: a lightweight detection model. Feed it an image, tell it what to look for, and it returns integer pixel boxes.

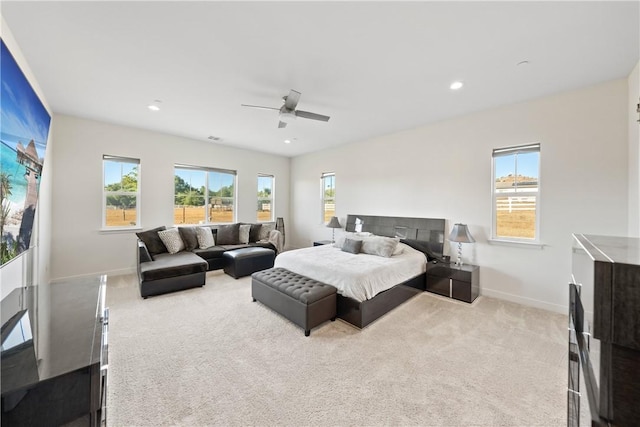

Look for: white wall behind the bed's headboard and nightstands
[291,79,628,313]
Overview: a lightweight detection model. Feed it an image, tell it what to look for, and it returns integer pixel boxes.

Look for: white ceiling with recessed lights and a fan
[1,1,640,156]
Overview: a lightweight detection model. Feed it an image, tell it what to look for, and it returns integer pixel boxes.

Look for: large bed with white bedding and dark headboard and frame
[274,215,445,328]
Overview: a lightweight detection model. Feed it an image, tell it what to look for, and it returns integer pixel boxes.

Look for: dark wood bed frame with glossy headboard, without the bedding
[337,215,446,328]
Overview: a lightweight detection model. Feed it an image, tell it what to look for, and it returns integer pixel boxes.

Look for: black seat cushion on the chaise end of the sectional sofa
[140,251,207,281]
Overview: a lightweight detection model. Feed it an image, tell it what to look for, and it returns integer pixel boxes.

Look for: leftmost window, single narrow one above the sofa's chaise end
[102,155,140,229]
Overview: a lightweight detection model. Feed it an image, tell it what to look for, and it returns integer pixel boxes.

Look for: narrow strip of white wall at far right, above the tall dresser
[628,61,640,237]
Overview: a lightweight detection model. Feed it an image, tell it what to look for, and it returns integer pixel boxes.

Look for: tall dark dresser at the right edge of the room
[567,234,640,427]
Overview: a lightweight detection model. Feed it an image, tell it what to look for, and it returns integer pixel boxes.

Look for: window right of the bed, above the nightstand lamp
[492,144,540,242]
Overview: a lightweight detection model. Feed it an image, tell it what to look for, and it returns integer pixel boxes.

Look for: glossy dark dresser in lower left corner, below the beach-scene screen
[1,276,109,427]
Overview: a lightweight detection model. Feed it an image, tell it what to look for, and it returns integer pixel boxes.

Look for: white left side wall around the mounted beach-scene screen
[0,16,54,298]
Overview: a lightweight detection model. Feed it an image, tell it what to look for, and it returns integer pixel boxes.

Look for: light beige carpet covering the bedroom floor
[107,271,567,426]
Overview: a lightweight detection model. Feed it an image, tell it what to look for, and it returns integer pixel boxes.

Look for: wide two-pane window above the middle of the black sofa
[173,165,236,224]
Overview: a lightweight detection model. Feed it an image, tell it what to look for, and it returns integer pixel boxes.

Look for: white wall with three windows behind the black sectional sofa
[52,115,290,279]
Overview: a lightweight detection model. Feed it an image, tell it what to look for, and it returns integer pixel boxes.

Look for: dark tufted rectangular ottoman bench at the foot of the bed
[251,268,336,337]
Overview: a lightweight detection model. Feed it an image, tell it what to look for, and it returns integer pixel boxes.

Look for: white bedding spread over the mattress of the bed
[274,243,427,301]
